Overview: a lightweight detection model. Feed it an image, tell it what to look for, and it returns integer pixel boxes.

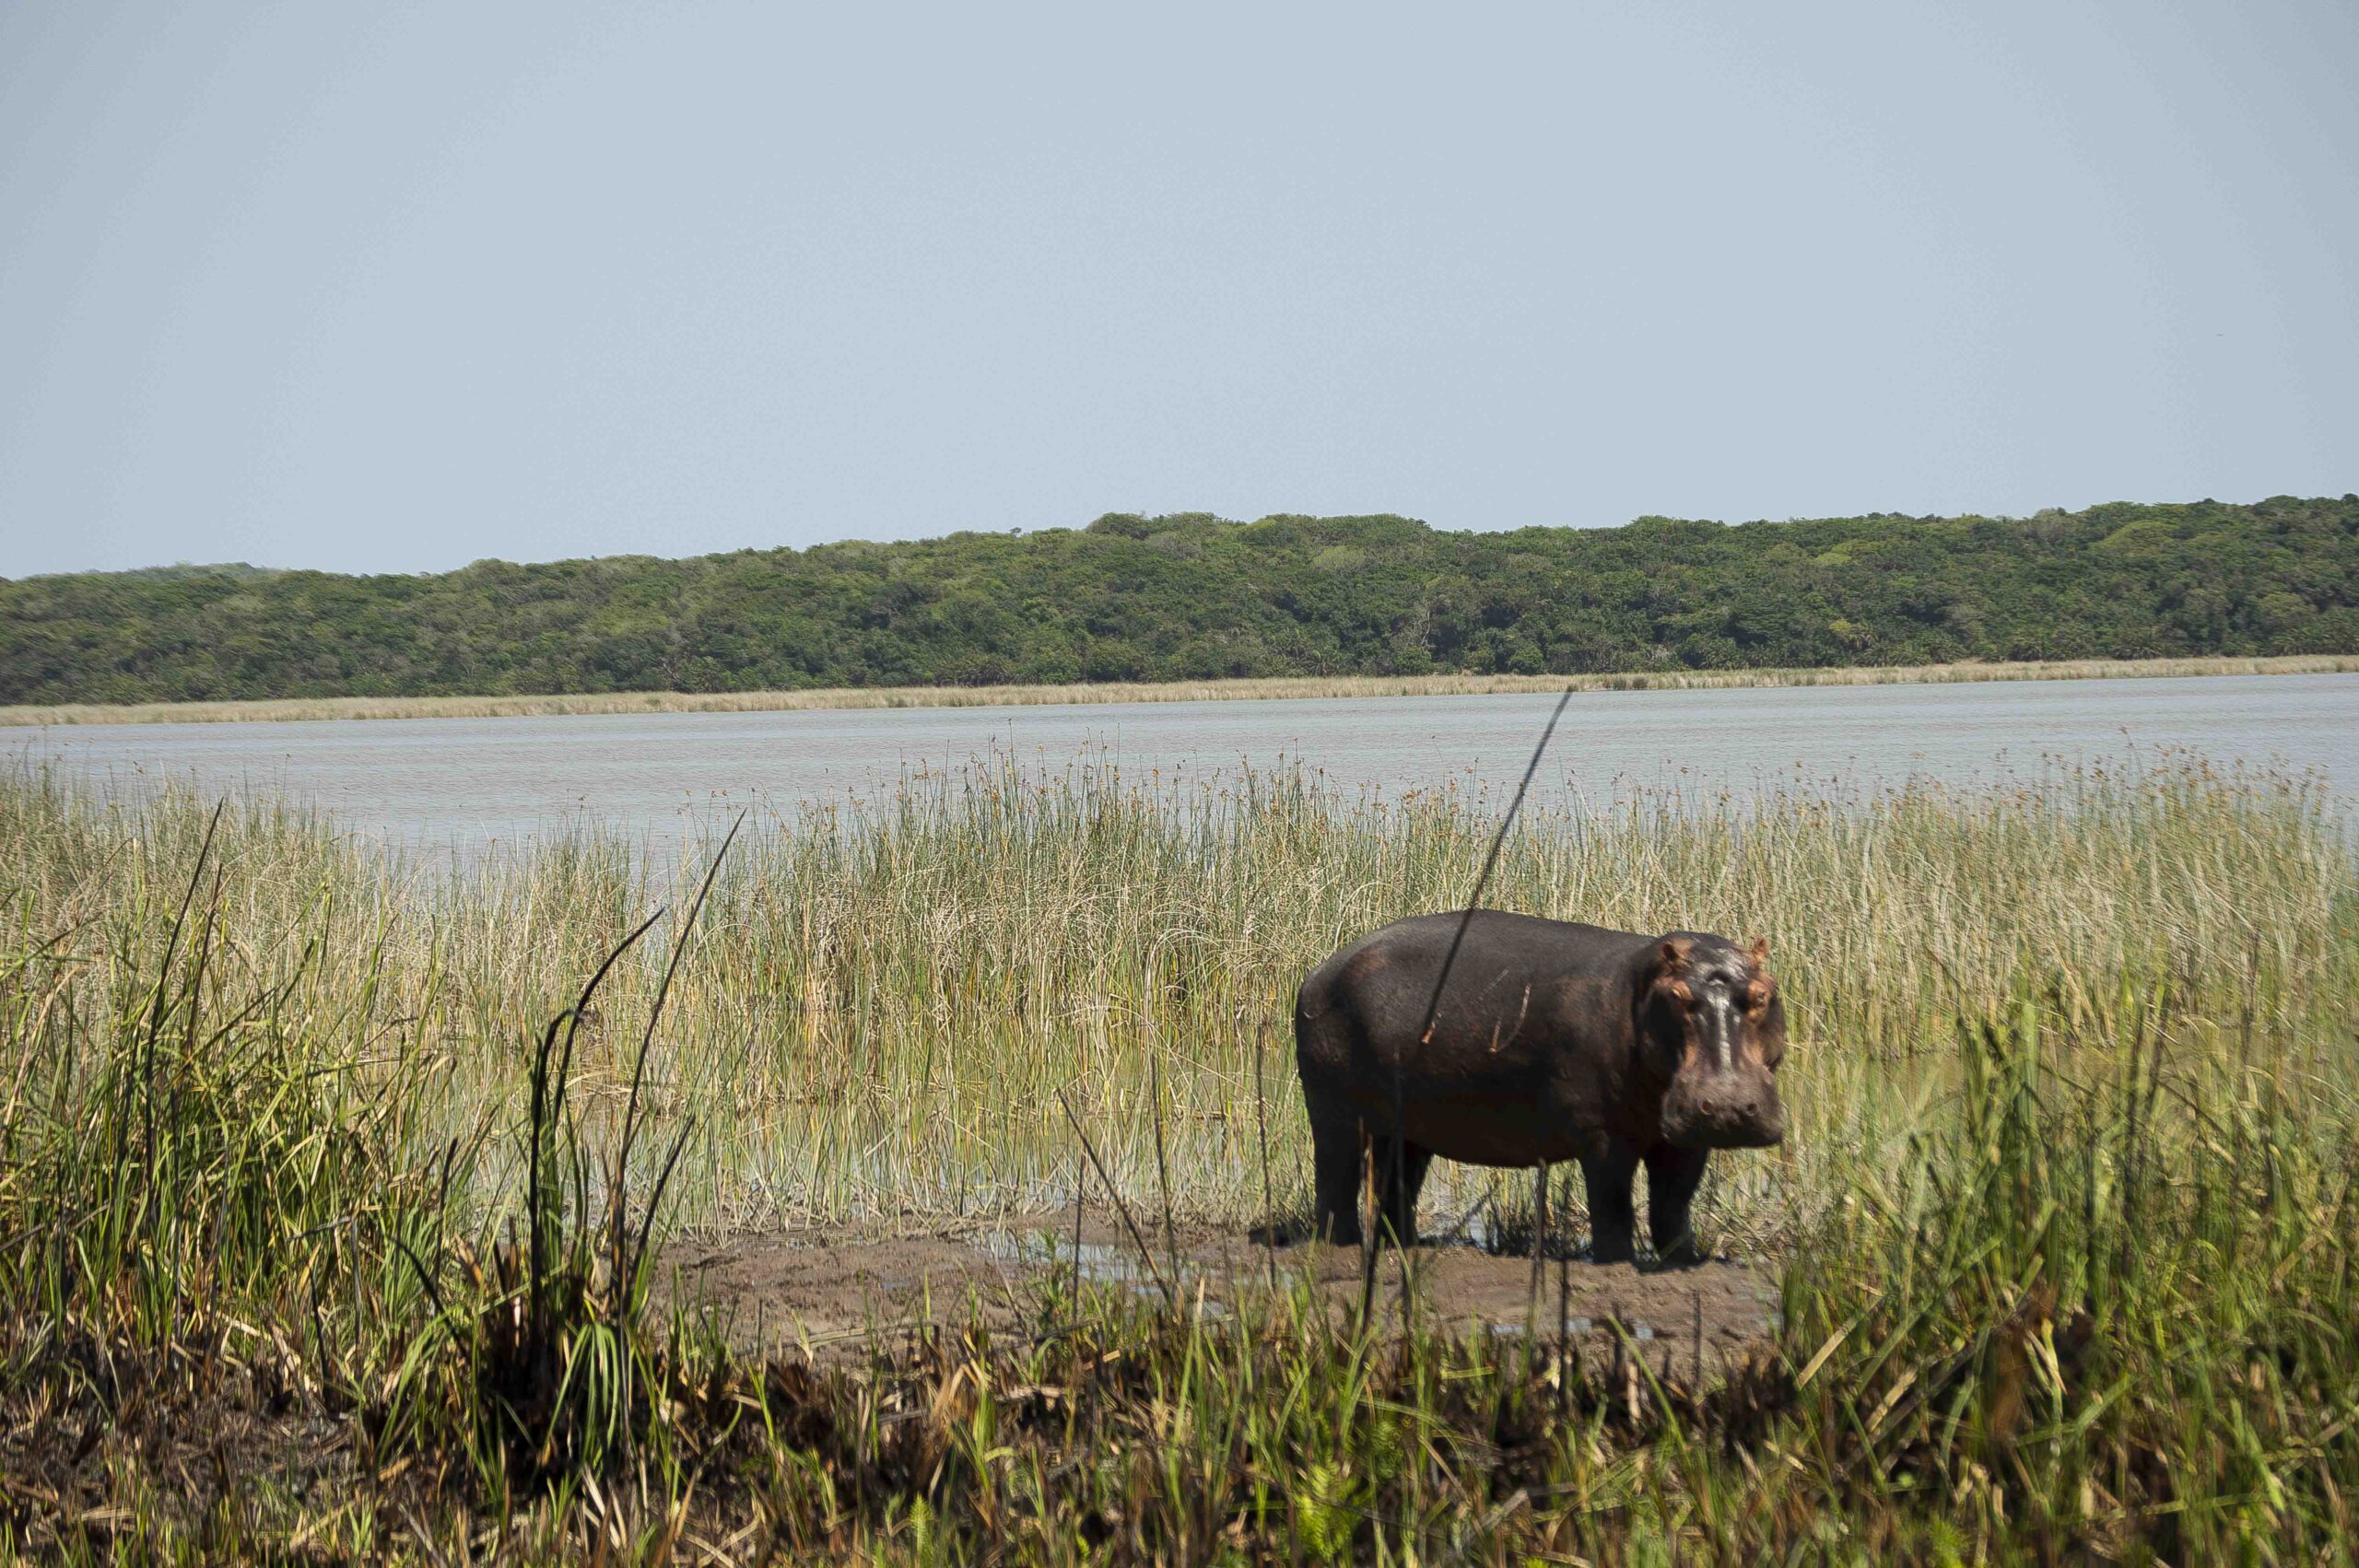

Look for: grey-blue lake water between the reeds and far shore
[0,674,2359,860]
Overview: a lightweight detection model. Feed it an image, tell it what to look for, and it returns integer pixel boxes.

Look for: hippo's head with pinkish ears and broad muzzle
[1637,931,1786,1148]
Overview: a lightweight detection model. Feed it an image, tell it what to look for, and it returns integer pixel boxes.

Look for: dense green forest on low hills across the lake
[0,495,2359,703]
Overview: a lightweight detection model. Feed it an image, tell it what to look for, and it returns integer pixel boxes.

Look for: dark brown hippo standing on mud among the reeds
[1295,910,1786,1264]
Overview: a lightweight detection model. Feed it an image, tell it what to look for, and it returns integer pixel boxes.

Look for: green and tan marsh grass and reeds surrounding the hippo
[0,757,2359,1561]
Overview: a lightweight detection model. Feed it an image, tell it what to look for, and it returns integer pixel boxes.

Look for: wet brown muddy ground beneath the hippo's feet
[663,1217,1777,1370]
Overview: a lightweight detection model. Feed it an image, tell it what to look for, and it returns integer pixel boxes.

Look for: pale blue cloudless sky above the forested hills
[0,0,2359,575]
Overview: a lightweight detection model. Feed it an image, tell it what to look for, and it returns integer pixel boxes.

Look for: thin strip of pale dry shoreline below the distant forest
[0,653,2359,729]
